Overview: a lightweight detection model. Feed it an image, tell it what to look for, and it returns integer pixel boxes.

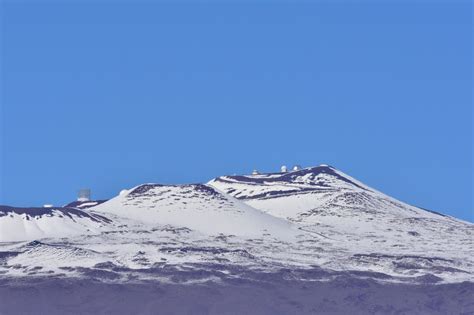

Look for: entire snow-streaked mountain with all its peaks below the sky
[0,165,474,314]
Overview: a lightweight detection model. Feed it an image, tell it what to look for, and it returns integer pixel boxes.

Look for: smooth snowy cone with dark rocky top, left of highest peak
[91,184,296,237]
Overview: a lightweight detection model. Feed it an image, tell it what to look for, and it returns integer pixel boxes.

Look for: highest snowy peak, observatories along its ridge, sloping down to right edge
[208,165,474,282]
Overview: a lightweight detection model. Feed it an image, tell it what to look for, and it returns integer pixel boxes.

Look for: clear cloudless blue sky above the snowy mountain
[0,0,474,221]
